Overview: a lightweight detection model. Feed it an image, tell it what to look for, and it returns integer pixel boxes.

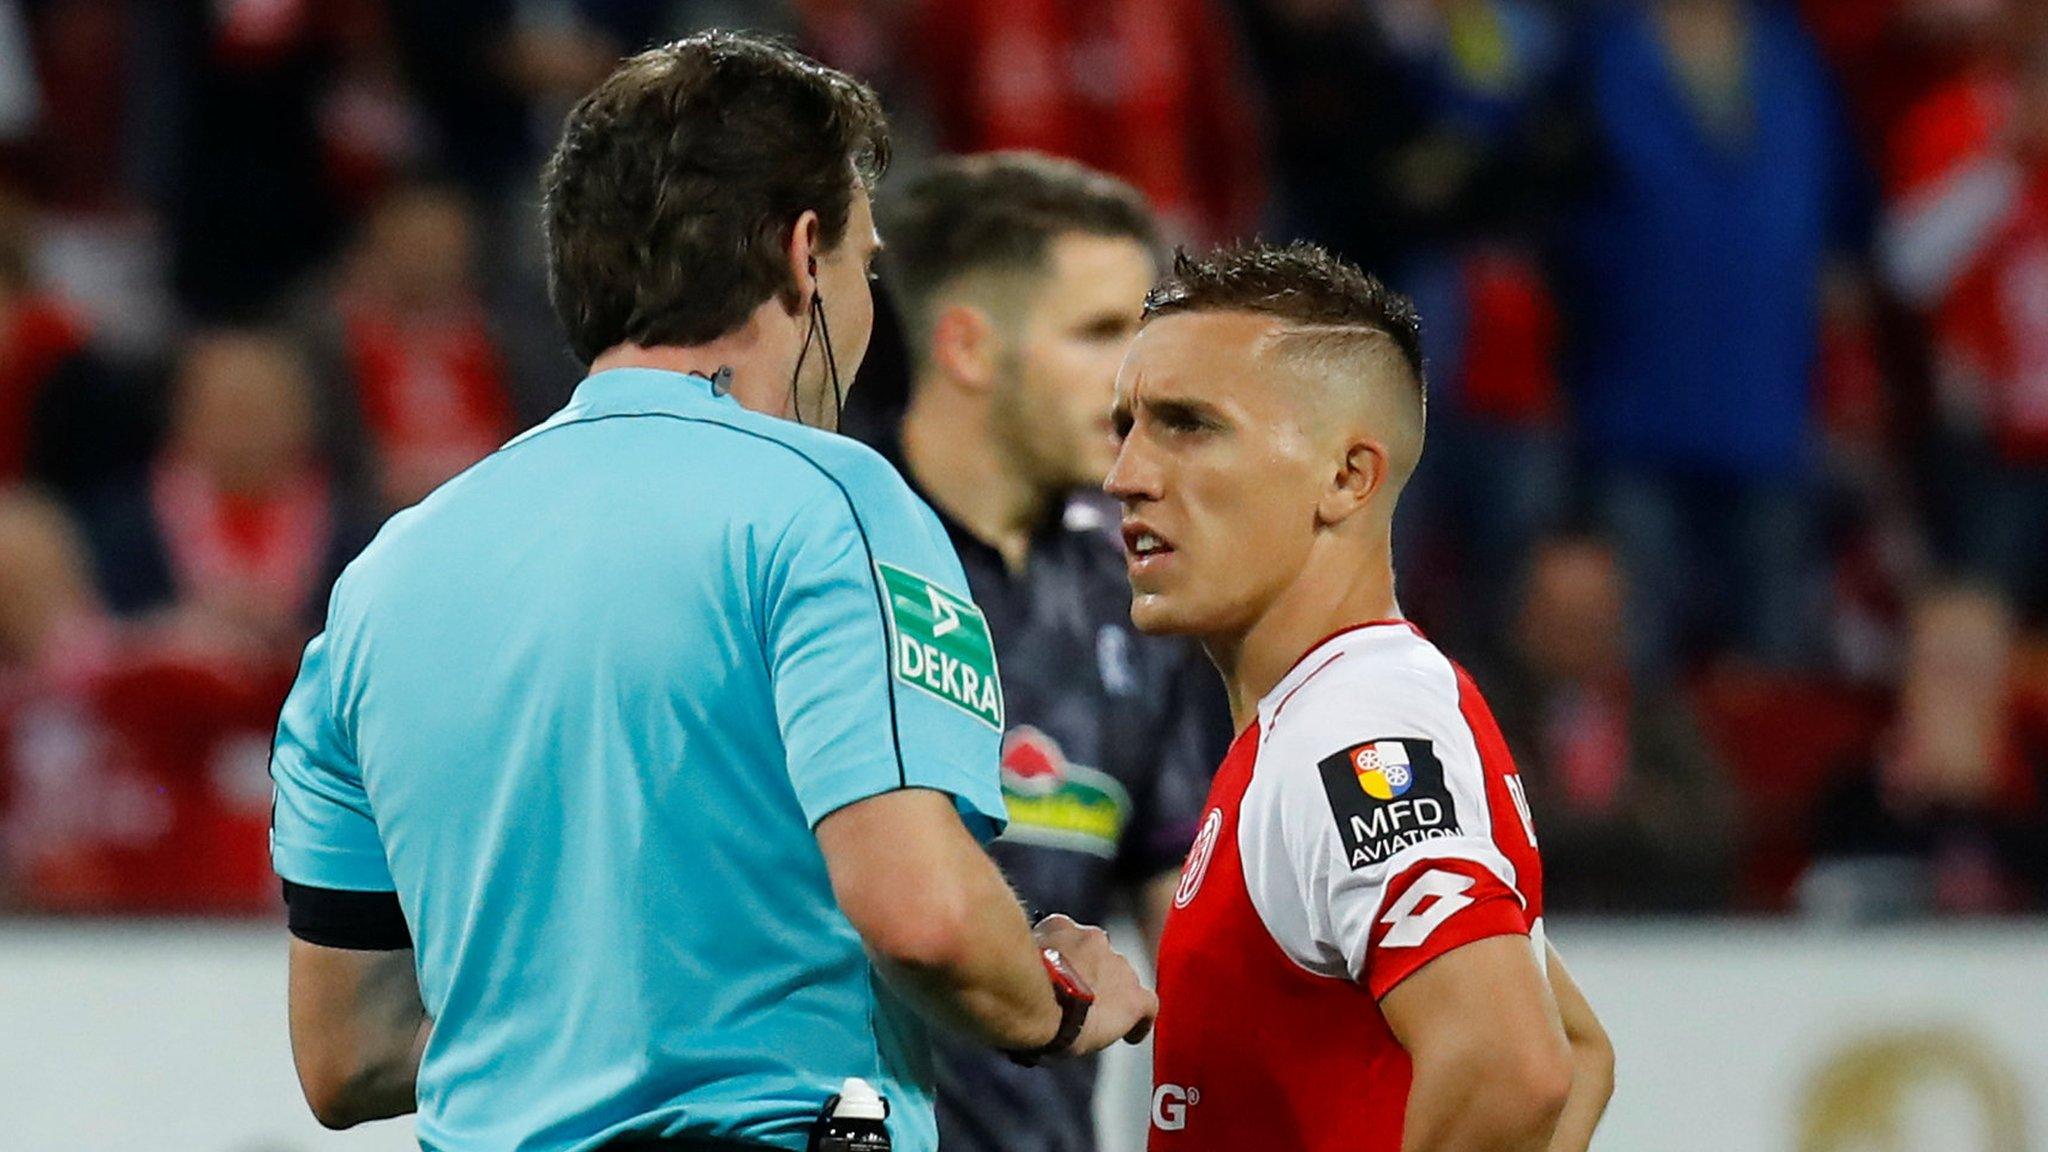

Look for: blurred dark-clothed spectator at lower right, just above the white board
[1800,586,2048,916]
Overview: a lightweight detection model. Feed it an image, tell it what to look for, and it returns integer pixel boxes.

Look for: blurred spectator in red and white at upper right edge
[1884,8,2048,611]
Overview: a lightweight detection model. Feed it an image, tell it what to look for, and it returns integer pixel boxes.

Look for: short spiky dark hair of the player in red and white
[1145,242,1427,430]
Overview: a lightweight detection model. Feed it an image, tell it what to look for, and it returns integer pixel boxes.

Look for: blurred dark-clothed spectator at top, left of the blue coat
[1237,0,1569,266]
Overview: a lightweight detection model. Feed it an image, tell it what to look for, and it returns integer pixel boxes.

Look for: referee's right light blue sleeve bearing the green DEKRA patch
[762,455,1008,840]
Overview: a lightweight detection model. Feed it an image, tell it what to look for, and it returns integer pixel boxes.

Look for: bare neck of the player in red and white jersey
[1204,543,1401,730]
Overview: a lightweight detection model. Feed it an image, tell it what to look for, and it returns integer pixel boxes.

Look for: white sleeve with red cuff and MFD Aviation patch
[1243,662,1532,996]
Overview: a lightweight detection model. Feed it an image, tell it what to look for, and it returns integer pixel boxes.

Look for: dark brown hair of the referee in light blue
[541,31,889,365]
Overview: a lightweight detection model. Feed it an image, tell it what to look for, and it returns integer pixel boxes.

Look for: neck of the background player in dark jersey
[903,387,1057,572]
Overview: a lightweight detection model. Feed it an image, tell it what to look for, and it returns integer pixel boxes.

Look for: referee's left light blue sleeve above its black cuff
[270,633,393,892]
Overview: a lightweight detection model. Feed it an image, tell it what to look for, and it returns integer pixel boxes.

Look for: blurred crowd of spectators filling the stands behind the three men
[0,0,2048,918]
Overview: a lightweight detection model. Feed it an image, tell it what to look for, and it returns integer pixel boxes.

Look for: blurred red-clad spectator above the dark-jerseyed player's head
[907,0,1266,242]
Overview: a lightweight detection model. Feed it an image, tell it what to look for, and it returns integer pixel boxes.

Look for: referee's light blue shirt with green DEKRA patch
[272,369,1004,1152]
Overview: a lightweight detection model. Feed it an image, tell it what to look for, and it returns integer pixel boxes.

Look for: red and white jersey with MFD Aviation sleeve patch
[1149,621,1542,1152]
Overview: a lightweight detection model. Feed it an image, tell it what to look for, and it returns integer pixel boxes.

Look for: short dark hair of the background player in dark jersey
[877,152,1159,359]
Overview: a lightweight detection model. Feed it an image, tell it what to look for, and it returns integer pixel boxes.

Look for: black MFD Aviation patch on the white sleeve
[1317,736,1458,869]
